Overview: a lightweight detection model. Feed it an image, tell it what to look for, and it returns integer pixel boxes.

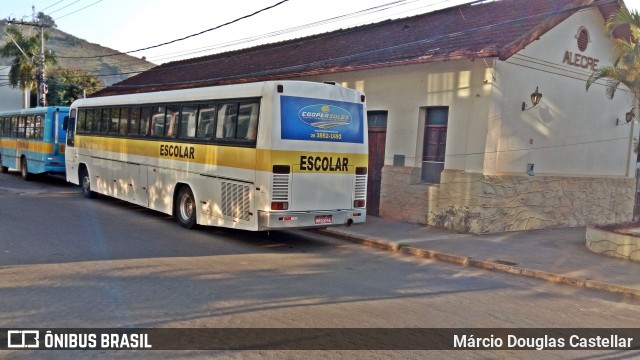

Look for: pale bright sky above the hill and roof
[0,0,640,64]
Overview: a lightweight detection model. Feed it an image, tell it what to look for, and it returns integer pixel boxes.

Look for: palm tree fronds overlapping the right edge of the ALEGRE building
[587,7,640,109]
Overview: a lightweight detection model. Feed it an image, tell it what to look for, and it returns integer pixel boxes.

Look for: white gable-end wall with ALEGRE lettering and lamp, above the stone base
[485,9,638,177]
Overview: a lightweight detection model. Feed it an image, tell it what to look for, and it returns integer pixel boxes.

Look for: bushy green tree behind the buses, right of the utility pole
[47,68,104,106]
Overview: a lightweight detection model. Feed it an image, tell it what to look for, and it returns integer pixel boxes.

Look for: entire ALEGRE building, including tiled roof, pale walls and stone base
[96,0,638,233]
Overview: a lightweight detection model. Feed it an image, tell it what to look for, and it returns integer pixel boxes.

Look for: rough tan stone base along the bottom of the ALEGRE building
[380,166,636,233]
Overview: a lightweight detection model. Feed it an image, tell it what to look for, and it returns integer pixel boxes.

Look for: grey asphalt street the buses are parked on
[0,173,640,359]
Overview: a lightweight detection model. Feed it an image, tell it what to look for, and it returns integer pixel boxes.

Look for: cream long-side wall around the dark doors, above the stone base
[303,60,493,171]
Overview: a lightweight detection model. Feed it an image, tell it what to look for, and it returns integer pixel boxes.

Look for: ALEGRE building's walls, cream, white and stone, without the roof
[302,9,638,232]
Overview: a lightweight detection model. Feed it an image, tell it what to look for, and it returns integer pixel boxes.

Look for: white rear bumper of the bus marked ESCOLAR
[258,209,367,230]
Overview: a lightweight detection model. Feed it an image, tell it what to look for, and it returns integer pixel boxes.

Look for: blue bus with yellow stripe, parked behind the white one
[0,106,69,180]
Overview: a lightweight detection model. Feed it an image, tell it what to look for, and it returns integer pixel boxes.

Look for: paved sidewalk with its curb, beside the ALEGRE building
[319,215,640,298]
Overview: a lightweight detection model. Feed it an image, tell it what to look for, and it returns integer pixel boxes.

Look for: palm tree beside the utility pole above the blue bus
[0,26,57,91]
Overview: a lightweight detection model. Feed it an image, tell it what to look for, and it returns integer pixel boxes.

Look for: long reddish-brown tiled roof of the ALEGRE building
[94,0,621,96]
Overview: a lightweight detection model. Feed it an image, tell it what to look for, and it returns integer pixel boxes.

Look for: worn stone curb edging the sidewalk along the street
[315,229,640,298]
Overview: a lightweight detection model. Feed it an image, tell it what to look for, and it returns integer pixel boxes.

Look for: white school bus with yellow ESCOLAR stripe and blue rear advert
[65,81,368,230]
